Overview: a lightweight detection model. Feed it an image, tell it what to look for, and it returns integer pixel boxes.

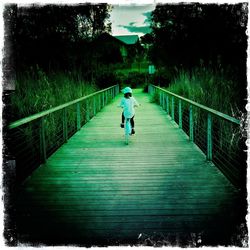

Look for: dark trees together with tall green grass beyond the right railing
[148,3,248,114]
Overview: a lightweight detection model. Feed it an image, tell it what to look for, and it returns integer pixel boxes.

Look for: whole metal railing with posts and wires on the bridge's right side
[148,85,246,188]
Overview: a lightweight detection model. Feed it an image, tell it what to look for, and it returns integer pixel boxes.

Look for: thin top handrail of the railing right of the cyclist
[152,84,240,125]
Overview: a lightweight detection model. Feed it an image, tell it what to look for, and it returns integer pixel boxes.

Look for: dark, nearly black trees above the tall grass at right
[146,3,247,74]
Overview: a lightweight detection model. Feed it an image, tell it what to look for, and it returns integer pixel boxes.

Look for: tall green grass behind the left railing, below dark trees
[11,67,97,120]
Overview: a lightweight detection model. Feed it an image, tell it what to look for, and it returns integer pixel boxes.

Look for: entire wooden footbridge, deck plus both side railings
[8,85,245,246]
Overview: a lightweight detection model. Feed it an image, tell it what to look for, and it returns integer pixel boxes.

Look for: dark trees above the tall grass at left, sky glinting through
[4,4,111,71]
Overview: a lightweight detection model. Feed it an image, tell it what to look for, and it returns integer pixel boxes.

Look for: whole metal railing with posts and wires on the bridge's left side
[6,85,119,182]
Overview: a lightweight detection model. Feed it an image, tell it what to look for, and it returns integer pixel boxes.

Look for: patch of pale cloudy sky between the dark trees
[110,4,155,36]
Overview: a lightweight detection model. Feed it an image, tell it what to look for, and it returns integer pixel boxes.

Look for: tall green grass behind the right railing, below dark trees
[168,67,242,117]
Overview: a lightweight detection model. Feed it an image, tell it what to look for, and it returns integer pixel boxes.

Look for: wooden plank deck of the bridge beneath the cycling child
[17,91,238,245]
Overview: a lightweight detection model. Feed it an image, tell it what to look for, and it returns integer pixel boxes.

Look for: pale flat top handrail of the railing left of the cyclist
[8,84,118,129]
